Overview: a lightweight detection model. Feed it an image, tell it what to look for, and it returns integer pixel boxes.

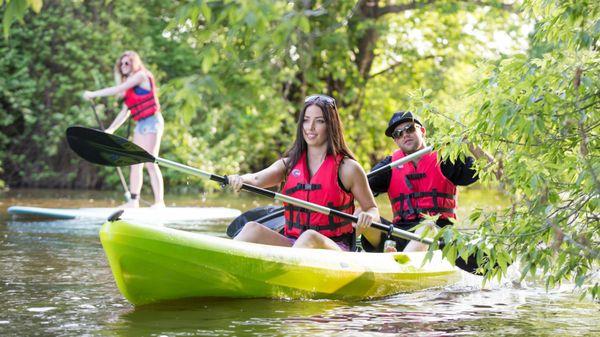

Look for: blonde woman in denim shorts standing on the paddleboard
[83,51,165,207]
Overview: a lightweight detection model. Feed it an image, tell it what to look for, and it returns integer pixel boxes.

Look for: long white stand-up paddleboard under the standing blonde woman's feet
[7,206,241,223]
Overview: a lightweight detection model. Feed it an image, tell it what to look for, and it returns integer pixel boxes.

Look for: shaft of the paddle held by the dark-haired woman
[154,157,433,245]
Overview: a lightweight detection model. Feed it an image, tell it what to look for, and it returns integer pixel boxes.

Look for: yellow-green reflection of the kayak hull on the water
[109,299,344,336]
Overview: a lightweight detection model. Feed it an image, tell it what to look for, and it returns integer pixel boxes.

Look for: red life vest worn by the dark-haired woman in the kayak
[282,153,354,247]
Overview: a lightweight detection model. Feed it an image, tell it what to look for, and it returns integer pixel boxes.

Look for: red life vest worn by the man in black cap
[388,150,457,224]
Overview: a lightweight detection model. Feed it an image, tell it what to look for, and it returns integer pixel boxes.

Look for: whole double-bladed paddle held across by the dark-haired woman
[67,126,477,273]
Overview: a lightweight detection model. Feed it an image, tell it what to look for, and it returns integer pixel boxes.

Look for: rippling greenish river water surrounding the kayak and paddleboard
[0,190,600,336]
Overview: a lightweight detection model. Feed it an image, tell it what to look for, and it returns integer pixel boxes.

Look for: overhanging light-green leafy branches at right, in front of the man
[420,0,600,298]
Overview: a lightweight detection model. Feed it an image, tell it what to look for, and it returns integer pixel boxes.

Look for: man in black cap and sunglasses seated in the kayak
[361,111,486,251]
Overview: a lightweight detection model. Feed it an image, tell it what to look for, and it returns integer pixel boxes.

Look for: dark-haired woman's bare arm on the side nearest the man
[340,159,379,236]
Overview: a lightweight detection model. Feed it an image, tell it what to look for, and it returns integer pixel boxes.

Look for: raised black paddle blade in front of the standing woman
[67,126,155,166]
